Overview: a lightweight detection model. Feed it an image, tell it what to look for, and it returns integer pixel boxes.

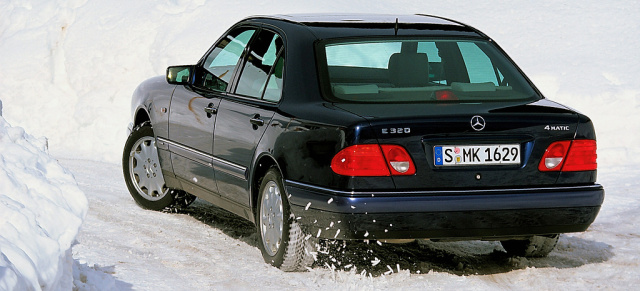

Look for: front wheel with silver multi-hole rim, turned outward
[122,122,195,211]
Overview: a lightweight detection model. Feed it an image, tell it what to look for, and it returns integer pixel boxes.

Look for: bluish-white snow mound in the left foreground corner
[0,117,88,290]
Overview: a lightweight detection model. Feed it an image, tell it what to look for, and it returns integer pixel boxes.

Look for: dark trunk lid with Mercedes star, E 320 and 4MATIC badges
[336,99,579,190]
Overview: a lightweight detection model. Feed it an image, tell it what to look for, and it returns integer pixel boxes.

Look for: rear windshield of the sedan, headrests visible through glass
[319,39,539,103]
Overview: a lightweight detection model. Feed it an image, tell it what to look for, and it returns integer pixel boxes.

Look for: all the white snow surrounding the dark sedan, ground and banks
[0,0,640,290]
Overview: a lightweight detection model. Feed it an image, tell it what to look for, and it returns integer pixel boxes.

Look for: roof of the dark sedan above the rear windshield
[245,13,486,39]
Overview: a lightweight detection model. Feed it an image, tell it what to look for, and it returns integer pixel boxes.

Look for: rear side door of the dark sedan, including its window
[213,29,284,205]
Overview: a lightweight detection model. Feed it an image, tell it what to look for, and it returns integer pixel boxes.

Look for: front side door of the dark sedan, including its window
[169,28,256,195]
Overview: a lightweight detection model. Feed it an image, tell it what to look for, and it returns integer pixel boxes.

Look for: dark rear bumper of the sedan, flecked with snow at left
[285,181,604,239]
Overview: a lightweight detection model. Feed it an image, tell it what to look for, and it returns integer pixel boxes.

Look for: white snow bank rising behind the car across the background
[0,0,640,166]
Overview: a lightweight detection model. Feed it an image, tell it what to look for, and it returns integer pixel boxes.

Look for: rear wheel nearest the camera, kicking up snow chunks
[256,167,316,272]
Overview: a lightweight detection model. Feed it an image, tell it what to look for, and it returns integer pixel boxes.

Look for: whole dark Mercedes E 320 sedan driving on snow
[122,15,604,271]
